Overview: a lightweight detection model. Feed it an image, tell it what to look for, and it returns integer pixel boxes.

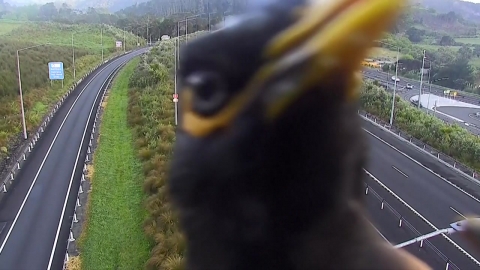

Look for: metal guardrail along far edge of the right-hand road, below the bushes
[358,110,480,185]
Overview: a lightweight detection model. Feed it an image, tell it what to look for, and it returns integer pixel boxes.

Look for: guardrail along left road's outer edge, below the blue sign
[0,52,128,202]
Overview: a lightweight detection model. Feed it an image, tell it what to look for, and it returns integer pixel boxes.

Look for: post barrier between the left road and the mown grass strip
[63,58,128,270]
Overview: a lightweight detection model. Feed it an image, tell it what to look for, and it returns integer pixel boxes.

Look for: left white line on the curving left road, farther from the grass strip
[0,56,127,254]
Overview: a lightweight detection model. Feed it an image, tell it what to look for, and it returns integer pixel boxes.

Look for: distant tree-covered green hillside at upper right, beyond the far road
[370,5,480,94]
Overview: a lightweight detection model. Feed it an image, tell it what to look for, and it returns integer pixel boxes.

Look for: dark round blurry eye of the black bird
[186,71,228,116]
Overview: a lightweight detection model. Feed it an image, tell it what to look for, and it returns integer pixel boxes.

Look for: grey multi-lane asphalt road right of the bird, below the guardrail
[365,121,480,269]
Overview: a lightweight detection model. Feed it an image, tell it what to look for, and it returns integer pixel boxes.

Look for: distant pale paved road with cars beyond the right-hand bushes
[363,68,480,135]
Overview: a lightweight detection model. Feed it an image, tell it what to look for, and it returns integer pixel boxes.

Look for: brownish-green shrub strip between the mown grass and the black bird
[128,34,204,270]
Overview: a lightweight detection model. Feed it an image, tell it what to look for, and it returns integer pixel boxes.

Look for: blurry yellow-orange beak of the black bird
[250,0,406,119]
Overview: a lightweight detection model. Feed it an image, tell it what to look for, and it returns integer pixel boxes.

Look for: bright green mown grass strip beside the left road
[80,59,150,270]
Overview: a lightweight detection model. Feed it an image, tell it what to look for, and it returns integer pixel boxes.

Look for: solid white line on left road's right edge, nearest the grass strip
[47,56,131,270]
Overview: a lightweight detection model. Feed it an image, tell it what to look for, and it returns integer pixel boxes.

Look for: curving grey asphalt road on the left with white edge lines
[0,49,147,270]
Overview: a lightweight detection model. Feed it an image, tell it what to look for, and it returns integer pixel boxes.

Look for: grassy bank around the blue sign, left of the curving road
[0,20,145,165]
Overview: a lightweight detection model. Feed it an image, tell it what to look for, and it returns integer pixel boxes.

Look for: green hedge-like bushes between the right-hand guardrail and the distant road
[360,81,480,171]
